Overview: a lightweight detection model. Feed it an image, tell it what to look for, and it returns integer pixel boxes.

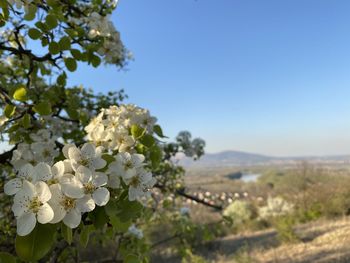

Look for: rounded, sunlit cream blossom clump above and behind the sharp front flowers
[85,104,157,152]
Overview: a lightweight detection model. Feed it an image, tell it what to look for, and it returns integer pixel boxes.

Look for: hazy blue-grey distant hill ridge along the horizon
[177,151,350,167]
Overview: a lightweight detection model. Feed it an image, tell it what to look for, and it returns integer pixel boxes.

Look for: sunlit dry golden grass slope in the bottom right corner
[211,218,350,263]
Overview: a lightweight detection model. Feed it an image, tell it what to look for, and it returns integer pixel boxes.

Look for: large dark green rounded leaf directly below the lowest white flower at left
[16,224,56,261]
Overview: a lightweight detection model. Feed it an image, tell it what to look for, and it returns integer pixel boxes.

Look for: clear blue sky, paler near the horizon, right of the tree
[70,0,350,156]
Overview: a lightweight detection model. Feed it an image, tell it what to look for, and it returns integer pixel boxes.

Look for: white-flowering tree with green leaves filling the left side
[0,0,211,262]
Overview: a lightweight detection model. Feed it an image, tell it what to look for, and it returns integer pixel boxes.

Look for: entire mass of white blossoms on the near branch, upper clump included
[4,105,156,236]
